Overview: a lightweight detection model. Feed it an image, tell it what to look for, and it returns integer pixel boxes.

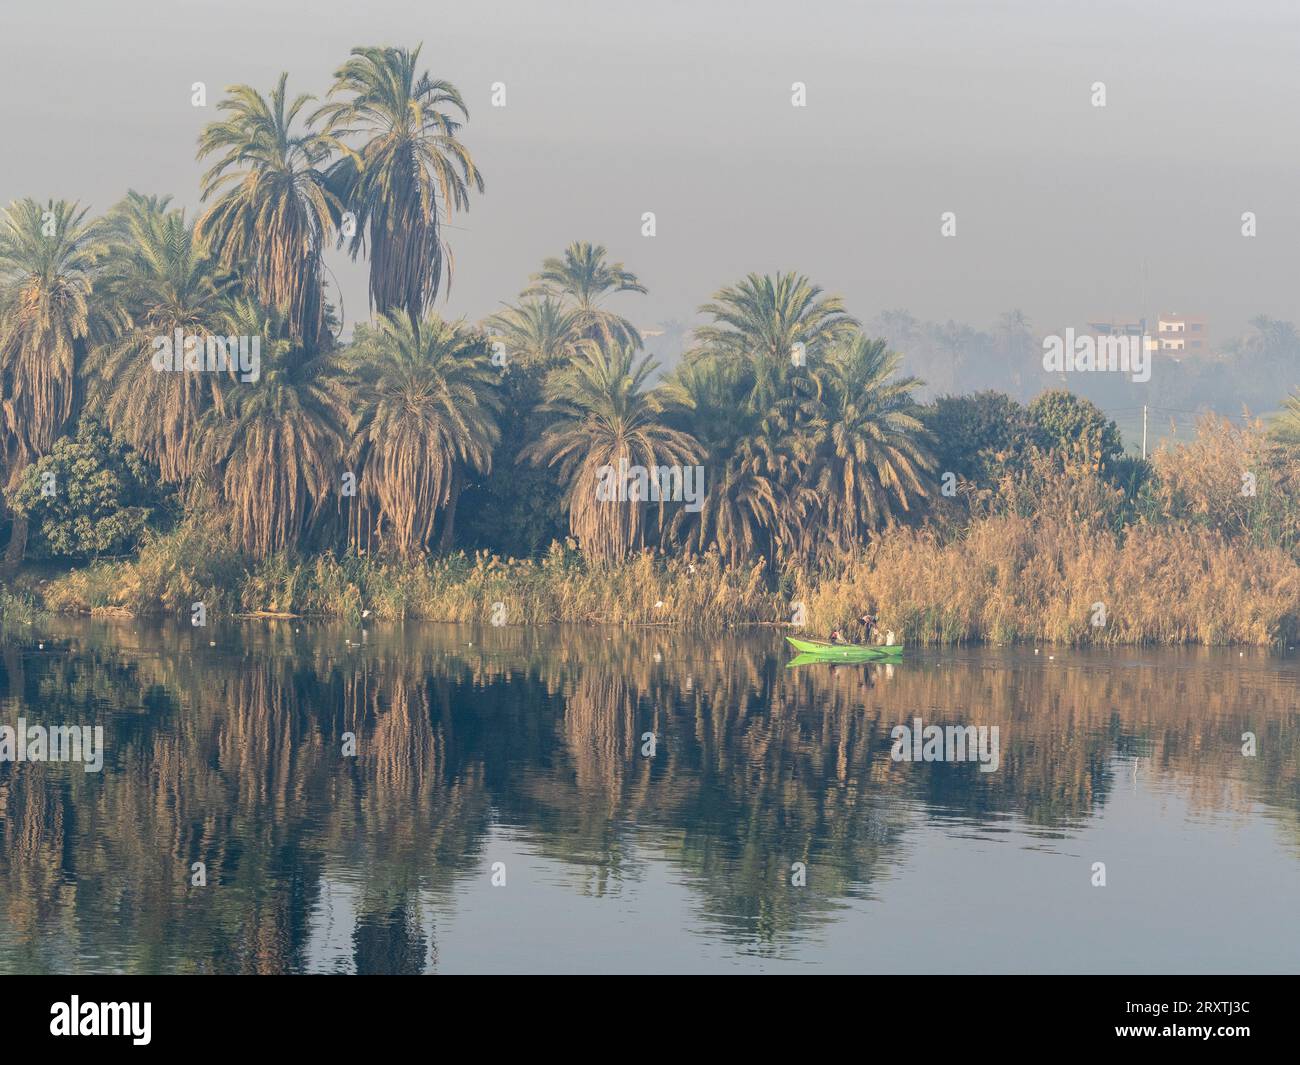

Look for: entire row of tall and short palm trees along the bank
[0,48,932,564]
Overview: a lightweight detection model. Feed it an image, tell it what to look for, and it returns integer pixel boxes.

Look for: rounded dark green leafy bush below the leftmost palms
[9,417,165,559]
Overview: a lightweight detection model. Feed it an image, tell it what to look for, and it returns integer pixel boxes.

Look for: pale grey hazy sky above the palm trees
[0,0,1300,339]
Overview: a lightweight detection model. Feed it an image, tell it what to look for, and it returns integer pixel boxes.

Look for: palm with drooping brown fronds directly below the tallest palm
[352,311,501,558]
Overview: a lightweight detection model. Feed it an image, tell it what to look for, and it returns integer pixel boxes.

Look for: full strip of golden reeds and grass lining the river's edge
[25,515,1300,646]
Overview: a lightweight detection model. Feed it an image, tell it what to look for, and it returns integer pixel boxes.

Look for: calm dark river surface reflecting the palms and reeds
[0,620,1300,973]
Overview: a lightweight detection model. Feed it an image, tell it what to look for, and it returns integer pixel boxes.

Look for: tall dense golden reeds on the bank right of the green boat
[797,515,1300,645]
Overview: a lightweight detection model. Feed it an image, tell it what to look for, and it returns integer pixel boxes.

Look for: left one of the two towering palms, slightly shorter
[196,74,347,350]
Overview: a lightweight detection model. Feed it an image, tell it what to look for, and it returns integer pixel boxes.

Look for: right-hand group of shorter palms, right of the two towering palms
[493,266,933,563]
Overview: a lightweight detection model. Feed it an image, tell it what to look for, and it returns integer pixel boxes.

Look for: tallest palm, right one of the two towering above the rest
[313,48,484,321]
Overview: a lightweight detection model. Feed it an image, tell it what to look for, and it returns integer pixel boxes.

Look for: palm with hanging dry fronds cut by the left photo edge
[0,199,104,570]
